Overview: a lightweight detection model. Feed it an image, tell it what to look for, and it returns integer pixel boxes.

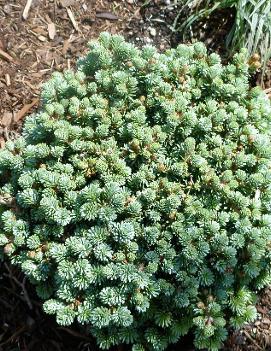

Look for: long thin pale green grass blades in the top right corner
[173,0,271,84]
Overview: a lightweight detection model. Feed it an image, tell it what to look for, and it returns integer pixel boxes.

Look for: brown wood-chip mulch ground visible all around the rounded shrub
[0,0,271,351]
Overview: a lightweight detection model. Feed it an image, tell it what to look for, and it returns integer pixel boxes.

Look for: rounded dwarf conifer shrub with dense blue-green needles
[0,33,271,351]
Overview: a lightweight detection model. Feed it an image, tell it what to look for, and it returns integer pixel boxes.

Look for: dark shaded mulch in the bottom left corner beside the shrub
[0,263,98,351]
